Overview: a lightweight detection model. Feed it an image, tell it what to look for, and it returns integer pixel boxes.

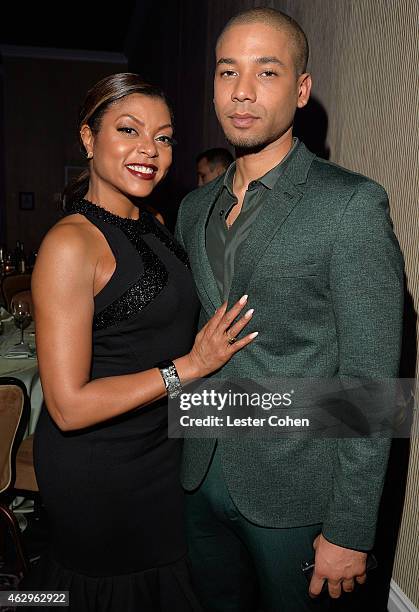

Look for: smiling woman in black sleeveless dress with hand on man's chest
[22,73,260,612]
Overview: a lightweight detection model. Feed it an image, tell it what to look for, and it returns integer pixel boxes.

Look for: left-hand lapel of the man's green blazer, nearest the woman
[188,180,223,317]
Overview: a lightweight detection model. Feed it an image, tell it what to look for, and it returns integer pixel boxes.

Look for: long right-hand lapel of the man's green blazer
[229,143,315,306]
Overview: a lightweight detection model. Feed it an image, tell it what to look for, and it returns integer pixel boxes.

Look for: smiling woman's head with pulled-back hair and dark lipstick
[64,72,174,218]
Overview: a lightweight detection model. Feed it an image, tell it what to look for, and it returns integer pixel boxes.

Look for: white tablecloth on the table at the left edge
[0,320,43,435]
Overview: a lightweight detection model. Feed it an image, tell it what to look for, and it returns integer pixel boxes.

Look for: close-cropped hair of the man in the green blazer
[217,7,309,76]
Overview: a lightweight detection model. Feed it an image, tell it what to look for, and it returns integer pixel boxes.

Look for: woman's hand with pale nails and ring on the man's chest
[175,295,258,382]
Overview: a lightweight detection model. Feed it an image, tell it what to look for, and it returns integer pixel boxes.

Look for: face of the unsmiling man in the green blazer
[214,23,311,150]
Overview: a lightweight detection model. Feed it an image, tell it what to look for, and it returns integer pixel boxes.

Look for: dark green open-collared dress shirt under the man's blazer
[205,138,298,300]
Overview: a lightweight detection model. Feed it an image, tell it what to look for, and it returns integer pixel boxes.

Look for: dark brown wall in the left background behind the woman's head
[3,55,126,252]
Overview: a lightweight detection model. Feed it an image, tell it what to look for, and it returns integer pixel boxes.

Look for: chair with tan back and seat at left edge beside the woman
[0,377,38,584]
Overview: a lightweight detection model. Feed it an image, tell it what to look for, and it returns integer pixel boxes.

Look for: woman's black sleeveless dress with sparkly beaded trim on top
[21,200,200,612]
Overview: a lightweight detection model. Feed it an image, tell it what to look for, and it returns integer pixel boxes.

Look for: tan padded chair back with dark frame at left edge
[0,377,30,493]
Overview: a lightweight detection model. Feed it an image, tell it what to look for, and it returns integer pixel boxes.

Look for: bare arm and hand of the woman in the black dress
[32,223,252,431]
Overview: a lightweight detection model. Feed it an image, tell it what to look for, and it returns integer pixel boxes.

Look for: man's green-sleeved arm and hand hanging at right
[310,182,403,597]
